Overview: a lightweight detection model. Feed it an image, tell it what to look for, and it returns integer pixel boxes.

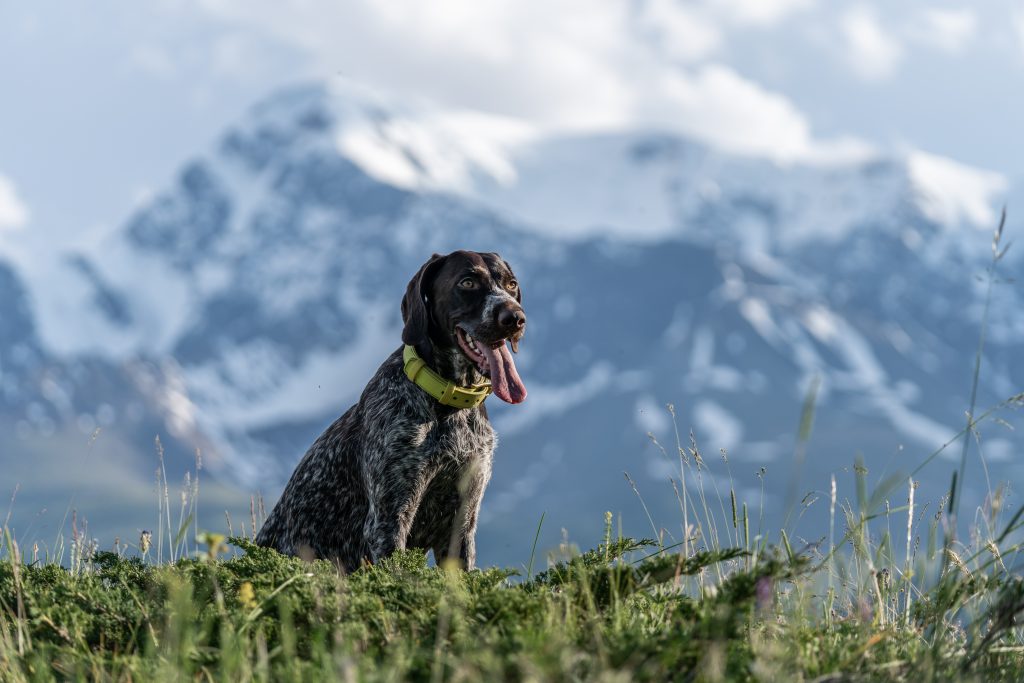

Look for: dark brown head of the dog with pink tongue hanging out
[401,251,526,403]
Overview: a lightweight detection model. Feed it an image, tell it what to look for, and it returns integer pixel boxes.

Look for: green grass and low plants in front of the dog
[6,218,1024,682]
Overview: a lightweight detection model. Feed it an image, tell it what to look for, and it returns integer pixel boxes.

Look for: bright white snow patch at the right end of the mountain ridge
[907,151,1009,227]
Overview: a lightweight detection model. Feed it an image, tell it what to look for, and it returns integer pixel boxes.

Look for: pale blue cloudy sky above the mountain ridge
[0,0,1024,253]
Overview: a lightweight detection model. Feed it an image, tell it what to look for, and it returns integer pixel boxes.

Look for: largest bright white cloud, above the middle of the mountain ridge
[190,0,855,160]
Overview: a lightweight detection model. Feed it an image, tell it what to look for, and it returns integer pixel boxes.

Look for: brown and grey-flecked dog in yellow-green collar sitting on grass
[256,251,526,571]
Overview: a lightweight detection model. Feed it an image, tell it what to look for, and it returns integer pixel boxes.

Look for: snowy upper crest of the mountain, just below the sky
[134,81,1008,254]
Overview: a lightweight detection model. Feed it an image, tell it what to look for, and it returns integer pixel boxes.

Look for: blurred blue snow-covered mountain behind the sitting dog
[0,86,1024,562]
